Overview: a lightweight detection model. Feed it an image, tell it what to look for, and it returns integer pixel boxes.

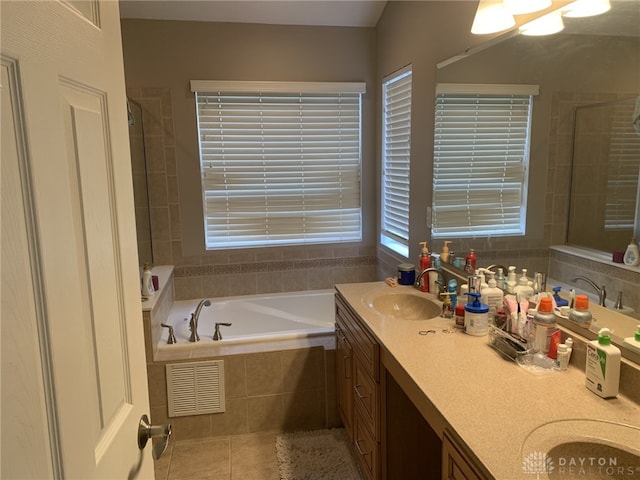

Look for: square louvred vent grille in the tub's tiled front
[166,360,225,417]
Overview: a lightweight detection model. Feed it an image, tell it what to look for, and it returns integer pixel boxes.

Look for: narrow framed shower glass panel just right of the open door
[127,99,153,266]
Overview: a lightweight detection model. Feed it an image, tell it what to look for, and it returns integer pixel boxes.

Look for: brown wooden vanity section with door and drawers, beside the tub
[336,293,381,480]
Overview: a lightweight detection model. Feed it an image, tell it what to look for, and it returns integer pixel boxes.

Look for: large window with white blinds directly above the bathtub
[191,81,365,249]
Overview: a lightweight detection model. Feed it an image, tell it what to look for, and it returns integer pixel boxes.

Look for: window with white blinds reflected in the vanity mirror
[431,84,538,238]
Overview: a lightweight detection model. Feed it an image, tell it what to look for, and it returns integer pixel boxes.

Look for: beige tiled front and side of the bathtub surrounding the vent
[144,282,340,440]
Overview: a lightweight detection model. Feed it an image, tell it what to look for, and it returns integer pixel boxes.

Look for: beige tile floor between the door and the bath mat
[155,432,280,480]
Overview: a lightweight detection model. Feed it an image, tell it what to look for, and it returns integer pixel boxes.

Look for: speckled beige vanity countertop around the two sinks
[336,282,640,480]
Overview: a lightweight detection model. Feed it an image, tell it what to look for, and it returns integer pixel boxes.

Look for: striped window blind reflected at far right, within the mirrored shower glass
[603,101,640,230]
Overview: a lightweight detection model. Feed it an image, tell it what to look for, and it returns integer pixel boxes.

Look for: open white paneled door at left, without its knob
[0,0,153,479]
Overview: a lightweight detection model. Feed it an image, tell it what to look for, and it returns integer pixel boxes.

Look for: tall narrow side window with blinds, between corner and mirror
[380,66,411,257]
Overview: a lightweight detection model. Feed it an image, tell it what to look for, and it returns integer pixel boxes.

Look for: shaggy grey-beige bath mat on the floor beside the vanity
[276,428,362,480]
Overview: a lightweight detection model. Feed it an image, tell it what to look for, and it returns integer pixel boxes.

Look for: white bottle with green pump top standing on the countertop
[585,328,620,398]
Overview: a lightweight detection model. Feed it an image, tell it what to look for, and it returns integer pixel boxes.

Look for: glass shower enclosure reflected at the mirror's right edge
[567,97,640,251]
